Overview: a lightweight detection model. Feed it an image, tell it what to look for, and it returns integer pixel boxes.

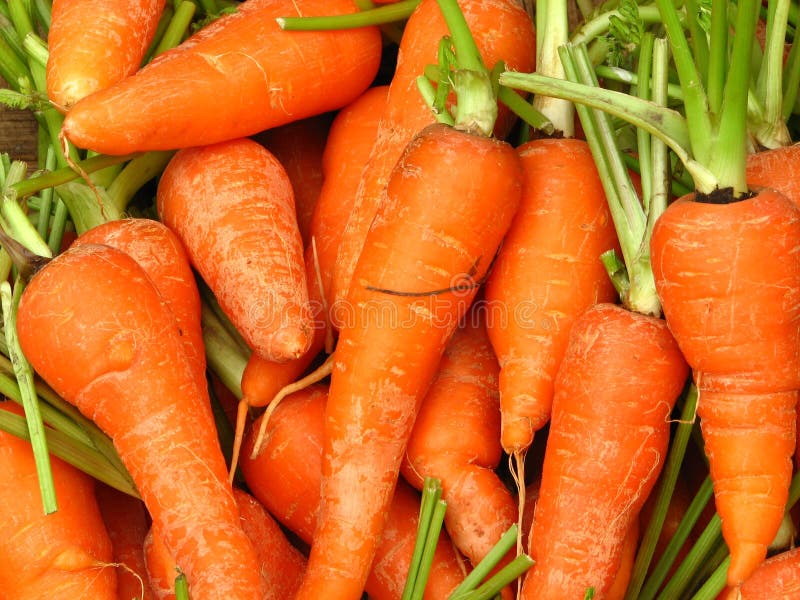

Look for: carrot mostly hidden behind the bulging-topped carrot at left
[73,218,206,387]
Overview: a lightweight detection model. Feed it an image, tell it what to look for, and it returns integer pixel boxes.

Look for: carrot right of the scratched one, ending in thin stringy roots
[486,138,618,454]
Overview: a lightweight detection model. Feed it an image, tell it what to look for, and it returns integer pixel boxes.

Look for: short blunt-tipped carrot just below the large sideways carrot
[157,138,312,361]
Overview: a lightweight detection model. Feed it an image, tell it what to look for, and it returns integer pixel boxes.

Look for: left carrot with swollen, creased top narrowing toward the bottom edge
[17,244,260,600]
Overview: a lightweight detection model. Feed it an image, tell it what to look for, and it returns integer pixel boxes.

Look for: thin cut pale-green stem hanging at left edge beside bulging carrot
[0,279,58,514]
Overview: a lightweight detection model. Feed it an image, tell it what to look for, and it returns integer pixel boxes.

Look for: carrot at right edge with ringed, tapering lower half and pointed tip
[650,190,800,586]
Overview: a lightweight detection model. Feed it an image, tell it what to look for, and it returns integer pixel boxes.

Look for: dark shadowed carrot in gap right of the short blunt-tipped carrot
[254,113,332,247]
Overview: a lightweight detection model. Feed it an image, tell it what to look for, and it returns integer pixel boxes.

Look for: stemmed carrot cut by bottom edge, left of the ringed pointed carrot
[522,304,688,600]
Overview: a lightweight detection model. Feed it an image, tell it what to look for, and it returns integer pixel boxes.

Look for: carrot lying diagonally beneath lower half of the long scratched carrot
[241,384,463,600]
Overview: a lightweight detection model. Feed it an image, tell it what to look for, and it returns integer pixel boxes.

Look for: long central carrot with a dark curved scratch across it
[298,124,521,599]
